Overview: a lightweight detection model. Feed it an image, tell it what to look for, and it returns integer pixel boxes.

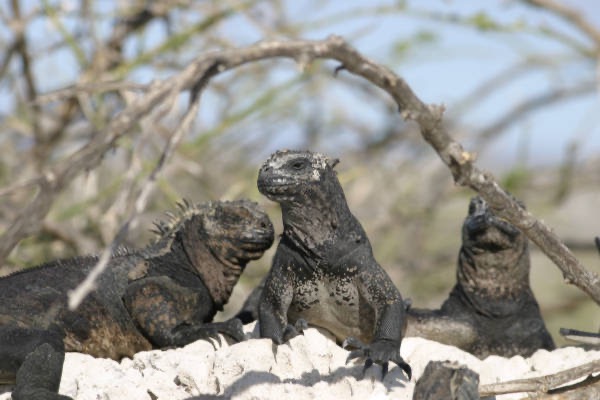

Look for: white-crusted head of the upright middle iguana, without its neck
[258,150,341,203]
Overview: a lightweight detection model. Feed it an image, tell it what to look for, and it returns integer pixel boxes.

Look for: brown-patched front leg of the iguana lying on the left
[123,276,245,348]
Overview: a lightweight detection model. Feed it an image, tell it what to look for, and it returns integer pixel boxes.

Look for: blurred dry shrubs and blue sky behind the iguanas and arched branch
[0,0,600,344]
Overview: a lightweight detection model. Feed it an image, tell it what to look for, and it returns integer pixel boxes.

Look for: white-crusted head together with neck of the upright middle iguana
[258,150,370,258]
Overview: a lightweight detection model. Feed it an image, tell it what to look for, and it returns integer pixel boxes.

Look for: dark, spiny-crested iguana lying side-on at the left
[0,201,274,400]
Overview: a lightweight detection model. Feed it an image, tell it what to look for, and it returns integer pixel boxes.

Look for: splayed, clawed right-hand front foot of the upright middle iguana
[342,336,412,381]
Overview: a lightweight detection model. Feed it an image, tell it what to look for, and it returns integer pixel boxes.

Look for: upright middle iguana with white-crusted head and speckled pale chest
[258,151,411,379]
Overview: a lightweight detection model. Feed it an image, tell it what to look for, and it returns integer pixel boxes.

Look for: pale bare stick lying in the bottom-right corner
[479,360,600,397]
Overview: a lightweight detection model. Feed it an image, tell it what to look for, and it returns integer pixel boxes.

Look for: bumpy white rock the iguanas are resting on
[0,325,600,400]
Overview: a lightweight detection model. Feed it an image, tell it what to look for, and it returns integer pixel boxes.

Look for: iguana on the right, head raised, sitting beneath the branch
[406,197,555,358]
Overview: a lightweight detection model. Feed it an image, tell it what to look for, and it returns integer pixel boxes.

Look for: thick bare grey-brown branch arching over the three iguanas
[0,36,600,304]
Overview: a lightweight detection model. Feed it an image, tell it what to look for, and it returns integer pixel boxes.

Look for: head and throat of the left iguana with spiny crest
[156,200,274,307]
